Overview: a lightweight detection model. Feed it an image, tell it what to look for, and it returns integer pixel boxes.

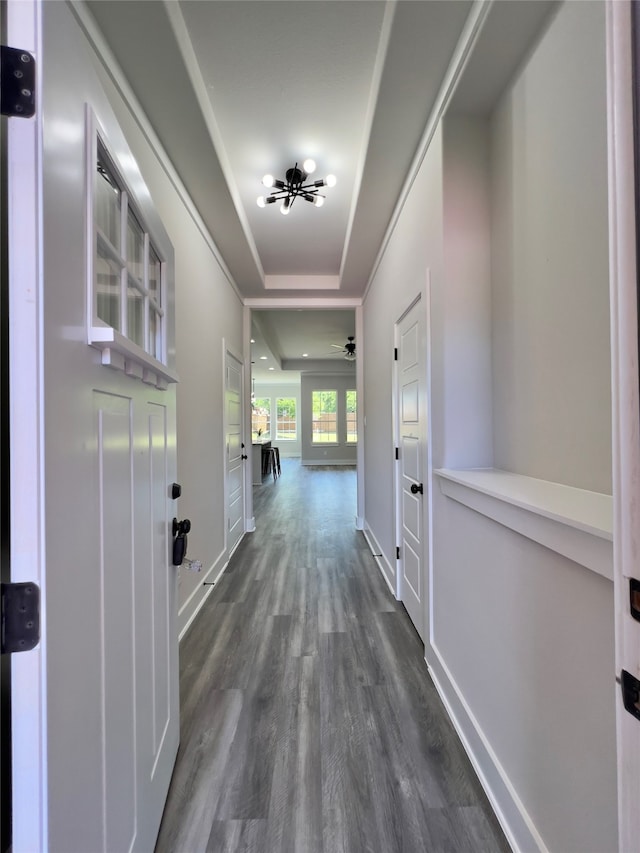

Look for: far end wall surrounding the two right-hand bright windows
[300,372,357,465]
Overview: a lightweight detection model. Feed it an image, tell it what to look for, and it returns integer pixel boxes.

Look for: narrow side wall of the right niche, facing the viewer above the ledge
[442,117,493,468]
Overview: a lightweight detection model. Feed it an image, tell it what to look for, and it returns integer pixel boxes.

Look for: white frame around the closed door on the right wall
[391,276,433,651]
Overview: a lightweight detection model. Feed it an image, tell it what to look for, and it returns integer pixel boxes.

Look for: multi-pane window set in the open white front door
[92,141,164,361]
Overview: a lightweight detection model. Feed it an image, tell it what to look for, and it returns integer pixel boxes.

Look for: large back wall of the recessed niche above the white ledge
[491,3,611,494]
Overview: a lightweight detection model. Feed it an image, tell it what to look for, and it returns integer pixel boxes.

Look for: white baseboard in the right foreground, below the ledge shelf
[425,645,549,853]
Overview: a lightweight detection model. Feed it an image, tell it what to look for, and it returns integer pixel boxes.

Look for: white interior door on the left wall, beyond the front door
[224,350,245,554]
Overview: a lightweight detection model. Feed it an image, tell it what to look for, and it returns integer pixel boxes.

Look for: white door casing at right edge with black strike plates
[607,0,640,853]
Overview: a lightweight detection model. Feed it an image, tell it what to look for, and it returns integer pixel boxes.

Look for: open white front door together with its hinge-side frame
[8,0,179,853]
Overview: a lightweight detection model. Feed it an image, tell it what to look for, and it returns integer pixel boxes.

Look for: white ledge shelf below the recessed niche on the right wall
[434,468,613,580]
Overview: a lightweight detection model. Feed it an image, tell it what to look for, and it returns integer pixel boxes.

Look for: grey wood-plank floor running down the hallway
[156,459,509,853]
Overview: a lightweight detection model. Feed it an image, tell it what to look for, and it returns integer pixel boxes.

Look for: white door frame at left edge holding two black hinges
[7,0,49,853]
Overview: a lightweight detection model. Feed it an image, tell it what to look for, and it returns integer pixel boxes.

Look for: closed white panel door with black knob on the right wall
[395,299,428,639]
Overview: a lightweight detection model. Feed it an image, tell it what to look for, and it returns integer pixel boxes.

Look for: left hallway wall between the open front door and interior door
[86,8,243,632]
